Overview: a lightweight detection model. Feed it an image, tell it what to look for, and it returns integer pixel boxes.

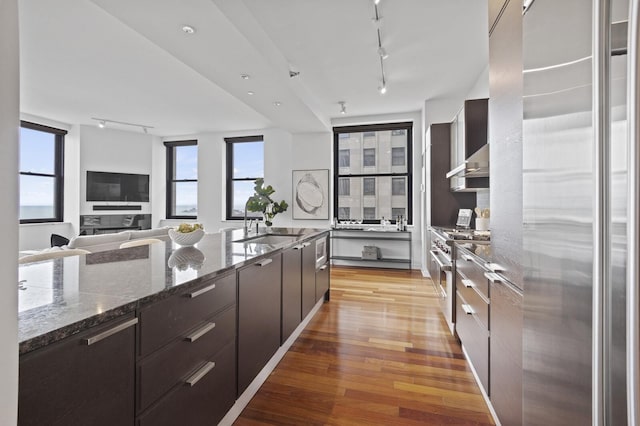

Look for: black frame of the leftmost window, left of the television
[18,120,68,224]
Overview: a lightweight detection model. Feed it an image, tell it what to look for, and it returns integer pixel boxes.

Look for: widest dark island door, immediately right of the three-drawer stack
[238,254,282,395]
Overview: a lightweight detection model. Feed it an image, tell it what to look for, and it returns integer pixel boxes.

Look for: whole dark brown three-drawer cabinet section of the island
[137,272,236,426]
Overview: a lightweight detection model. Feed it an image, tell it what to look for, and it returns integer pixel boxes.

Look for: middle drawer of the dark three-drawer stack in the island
[138,306,236,411]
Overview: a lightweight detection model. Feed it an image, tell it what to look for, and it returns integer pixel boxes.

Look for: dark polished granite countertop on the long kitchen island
[18,228,328,354]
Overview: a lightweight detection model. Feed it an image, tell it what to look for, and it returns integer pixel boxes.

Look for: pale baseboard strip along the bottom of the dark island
[218,298,324,426]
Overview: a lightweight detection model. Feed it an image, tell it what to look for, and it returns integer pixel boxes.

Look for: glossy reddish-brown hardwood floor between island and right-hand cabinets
[235,267,494,426]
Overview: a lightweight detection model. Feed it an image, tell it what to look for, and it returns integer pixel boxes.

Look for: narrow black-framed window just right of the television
[164,140,198,219]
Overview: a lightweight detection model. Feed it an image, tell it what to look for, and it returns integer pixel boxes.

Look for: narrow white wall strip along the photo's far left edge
[0,0,20,426]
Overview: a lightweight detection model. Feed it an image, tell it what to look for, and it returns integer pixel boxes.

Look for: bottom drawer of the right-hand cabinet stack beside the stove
[456,291,490,395]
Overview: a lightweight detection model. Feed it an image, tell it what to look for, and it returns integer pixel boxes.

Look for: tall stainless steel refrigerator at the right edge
[524,0,640,425]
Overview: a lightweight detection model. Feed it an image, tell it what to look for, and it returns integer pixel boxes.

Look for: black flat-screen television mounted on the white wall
[87,171,149,202]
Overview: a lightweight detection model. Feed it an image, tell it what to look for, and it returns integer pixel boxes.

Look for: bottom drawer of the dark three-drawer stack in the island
[138,342,236,426]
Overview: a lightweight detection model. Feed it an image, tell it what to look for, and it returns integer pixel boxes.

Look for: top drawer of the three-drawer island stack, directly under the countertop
[139,274,236,356]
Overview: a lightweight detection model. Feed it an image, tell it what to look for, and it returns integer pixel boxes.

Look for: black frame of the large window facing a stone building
[333,121,413,225]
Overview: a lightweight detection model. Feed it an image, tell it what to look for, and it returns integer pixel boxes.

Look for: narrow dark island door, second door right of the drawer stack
[282,245,302,343]
